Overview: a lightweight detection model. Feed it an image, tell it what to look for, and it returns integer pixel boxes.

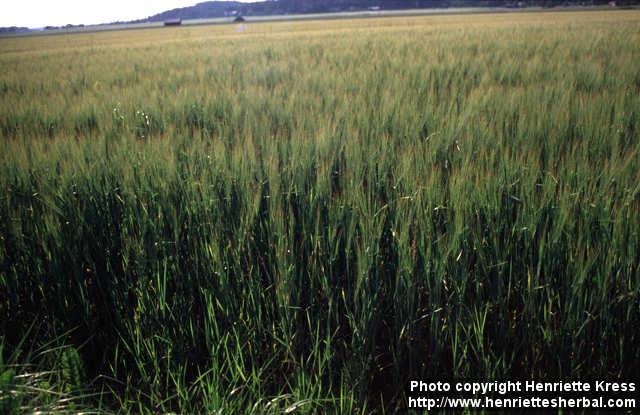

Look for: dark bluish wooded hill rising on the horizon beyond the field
[136,0,640,22]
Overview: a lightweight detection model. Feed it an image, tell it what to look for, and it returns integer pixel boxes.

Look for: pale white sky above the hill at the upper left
[0,0,255,28]
